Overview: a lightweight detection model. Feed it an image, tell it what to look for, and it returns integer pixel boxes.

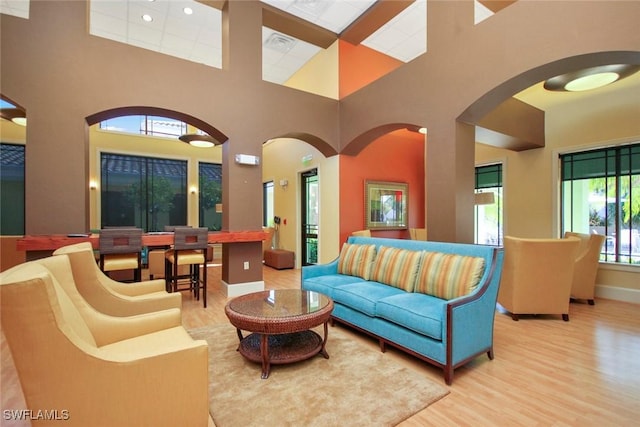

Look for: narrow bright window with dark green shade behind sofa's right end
[474,163,503,246]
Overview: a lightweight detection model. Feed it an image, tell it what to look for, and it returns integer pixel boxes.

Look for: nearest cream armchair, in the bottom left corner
[0,256,213,427]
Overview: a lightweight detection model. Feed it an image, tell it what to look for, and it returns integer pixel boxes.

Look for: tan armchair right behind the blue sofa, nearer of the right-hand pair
[498,236,580,321]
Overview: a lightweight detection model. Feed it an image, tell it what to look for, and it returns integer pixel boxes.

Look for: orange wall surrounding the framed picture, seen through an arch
[340,130,425,243]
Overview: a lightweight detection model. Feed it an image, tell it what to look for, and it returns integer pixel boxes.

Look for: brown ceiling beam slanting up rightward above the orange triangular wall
[340,0,414,45]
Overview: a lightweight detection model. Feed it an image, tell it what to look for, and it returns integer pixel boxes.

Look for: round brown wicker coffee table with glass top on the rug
[224,289,333,379]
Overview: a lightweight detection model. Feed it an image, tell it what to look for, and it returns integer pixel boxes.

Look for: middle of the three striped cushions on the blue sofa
[371,246,422,292]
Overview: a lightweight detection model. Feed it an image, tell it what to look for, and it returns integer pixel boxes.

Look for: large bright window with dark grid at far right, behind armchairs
[560,144,640,264]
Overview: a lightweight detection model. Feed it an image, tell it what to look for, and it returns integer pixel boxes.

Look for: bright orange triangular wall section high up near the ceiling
[338,40,403,99]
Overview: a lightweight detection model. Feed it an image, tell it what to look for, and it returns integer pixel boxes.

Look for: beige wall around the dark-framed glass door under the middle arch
[262,138,340,266]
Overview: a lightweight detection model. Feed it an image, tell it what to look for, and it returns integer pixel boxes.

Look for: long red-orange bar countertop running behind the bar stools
[16,230,268,251]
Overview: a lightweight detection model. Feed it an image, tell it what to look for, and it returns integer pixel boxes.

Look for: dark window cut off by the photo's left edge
[0,144,25,236]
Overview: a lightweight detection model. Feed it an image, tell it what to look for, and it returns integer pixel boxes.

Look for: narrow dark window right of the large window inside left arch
[198,163,222,231]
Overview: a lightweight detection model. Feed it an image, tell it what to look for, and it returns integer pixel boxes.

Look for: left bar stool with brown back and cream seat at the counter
[98,227,142,282]
